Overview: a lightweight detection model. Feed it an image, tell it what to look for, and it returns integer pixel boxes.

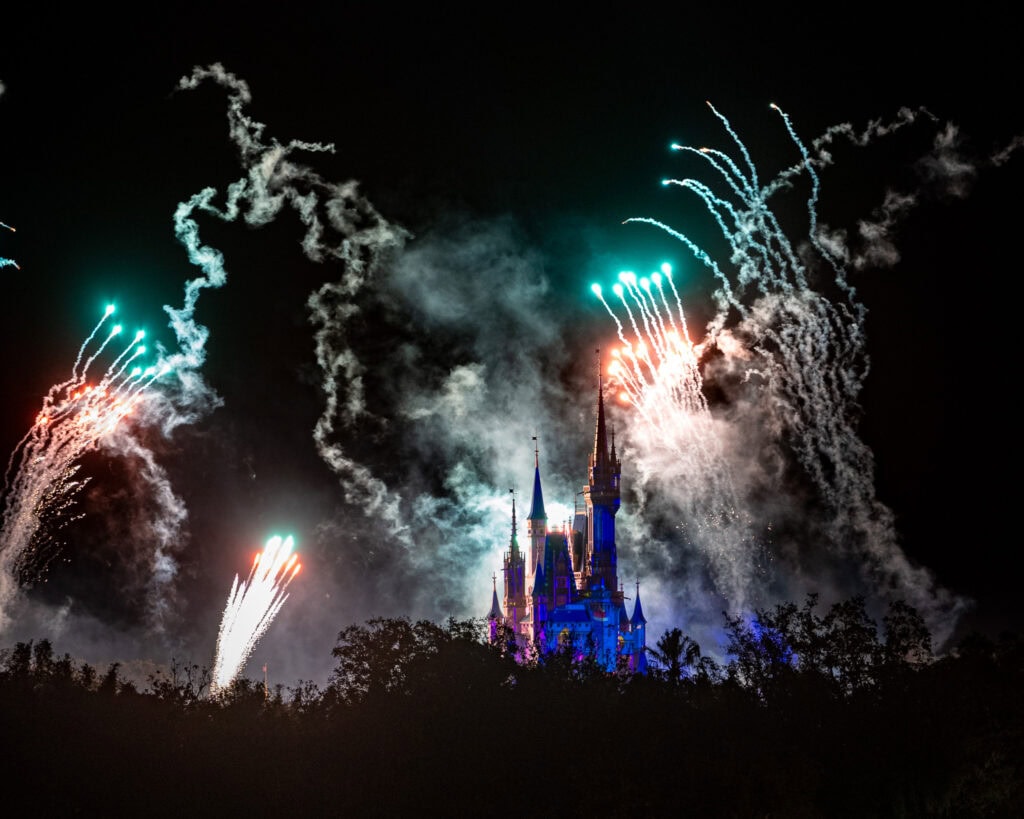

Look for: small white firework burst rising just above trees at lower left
[210,535,302,696]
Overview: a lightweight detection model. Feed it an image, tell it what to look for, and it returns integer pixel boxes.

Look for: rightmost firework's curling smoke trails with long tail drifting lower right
[628,103,963,642]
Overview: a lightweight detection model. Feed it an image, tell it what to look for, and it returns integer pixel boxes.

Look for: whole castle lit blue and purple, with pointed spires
[487,378,646,673]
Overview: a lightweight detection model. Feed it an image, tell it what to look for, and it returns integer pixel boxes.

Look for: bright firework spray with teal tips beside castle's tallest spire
[592,264,764,610]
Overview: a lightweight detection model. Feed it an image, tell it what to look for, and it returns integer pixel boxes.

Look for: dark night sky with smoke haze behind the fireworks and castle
[0,4,1024,683]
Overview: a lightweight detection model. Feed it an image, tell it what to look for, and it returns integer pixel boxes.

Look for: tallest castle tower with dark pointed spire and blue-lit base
[583,378,622,596]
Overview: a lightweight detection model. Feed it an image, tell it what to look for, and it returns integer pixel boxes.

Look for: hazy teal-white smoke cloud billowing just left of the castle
[309,212,596,616]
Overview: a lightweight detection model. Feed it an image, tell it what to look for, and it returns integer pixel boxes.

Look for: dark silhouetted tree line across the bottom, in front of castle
[0,595,1024,817]
